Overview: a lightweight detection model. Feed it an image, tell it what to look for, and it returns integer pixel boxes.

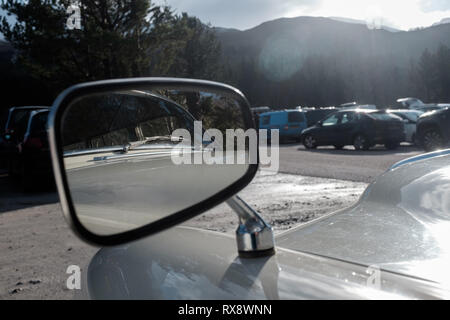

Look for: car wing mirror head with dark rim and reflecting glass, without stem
[48,78,259,246]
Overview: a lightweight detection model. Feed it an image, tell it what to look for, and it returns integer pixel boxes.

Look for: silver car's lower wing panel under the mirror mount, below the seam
[83,227,450,300]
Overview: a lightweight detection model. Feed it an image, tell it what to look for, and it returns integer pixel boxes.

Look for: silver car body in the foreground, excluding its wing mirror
[80,151,450,299]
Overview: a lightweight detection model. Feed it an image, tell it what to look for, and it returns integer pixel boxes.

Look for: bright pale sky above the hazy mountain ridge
[154,0,450,30]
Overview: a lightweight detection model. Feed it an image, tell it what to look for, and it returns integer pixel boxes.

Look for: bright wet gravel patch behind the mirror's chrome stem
[187,172,367,233]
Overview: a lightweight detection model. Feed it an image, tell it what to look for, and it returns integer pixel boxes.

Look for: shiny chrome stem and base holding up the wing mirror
[227,196,275,258]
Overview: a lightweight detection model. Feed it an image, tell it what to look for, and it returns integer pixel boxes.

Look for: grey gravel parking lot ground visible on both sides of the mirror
[0,145,418,299]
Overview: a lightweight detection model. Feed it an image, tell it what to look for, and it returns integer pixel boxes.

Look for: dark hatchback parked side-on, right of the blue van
[301,110,405,150]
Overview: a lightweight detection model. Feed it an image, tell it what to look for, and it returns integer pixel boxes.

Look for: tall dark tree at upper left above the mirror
[0,0,169,90]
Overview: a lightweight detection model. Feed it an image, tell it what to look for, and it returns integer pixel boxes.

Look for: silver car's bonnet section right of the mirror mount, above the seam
[277,156,450,286]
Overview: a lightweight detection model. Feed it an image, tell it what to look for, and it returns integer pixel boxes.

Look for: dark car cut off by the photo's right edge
[417,108,450,151]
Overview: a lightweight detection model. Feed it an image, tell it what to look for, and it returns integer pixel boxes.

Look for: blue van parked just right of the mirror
[259,110,308,141]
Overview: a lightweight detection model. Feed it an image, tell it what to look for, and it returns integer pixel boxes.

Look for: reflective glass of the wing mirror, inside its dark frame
[60,88,257,236]
